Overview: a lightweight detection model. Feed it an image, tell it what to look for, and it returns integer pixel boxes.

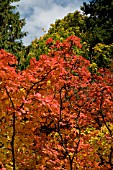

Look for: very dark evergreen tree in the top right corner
[81,0,113,62]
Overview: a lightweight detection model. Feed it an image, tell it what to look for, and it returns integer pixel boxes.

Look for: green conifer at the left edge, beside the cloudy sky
[0,0,26,55]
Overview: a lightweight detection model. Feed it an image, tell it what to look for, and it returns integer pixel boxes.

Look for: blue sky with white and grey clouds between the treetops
[14,0,89,46]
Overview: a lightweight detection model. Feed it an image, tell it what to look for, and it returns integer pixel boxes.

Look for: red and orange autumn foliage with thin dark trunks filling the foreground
[0,36,113,170]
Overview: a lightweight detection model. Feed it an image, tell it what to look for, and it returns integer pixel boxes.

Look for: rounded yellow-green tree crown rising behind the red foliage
[22,7,113,68]
